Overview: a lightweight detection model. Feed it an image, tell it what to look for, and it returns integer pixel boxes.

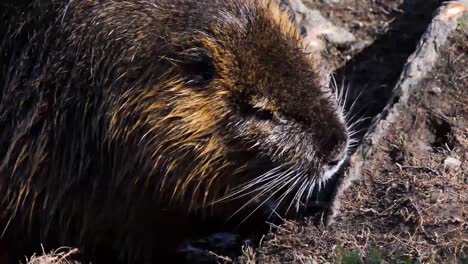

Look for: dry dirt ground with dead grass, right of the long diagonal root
[239,5,468,263]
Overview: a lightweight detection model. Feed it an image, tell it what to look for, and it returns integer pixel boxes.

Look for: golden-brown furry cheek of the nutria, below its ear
[109,81,243,203]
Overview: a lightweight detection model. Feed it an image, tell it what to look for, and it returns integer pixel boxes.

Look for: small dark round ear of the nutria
[182,48,216,85]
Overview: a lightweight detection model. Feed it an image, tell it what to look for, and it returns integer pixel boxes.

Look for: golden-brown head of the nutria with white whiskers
[96,0,349,211]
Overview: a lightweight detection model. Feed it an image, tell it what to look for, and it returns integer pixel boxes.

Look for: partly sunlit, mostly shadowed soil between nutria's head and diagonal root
[320,0,442,132]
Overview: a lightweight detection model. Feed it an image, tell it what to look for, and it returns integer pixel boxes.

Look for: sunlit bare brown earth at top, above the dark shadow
[303,0,424,68]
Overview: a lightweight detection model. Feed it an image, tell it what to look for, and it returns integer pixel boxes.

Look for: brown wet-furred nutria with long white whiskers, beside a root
[0,0,350,262]
